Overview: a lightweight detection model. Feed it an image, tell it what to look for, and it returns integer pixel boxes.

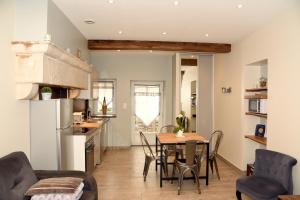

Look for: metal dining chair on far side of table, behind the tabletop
[159,125,183,177]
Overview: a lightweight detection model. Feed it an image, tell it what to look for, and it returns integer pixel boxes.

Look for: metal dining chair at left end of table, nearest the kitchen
[140,131,166,181]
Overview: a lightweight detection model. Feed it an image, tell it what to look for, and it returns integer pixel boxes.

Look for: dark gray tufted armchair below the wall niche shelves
[236,149,297,200]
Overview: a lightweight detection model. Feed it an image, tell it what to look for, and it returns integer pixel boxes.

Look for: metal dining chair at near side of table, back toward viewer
[171,140,204,195]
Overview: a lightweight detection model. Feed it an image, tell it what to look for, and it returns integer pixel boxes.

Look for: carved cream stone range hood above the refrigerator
[12,41,92,99]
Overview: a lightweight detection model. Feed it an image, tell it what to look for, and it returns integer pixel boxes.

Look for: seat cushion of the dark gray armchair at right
[236,176,287,200]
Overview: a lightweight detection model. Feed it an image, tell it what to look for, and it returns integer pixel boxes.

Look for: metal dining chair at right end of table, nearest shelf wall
[209,130,224,180]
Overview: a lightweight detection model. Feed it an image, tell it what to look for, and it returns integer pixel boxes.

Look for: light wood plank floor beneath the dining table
[94,147,246,200]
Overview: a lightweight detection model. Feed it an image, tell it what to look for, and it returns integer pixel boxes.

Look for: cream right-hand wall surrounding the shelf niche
[214,2,300,194]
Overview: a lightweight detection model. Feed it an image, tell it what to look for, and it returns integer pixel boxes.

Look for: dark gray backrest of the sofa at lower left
[0,152,37,200]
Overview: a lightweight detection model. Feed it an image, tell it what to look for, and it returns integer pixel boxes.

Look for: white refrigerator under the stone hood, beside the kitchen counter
[30,99,73,170]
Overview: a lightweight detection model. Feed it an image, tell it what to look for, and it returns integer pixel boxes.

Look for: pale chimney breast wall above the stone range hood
[14,0,89,60]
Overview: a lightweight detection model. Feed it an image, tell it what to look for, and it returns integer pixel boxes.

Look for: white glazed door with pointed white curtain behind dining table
[131,81,164,145]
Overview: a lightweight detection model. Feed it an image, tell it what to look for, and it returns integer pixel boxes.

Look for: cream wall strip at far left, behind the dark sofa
[0,0,29,157]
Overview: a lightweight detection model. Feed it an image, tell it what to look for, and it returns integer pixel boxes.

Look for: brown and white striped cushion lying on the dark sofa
[25,177,83,196]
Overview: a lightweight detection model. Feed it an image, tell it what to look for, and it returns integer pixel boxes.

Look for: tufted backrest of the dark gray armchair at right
[254,149,297,194]
